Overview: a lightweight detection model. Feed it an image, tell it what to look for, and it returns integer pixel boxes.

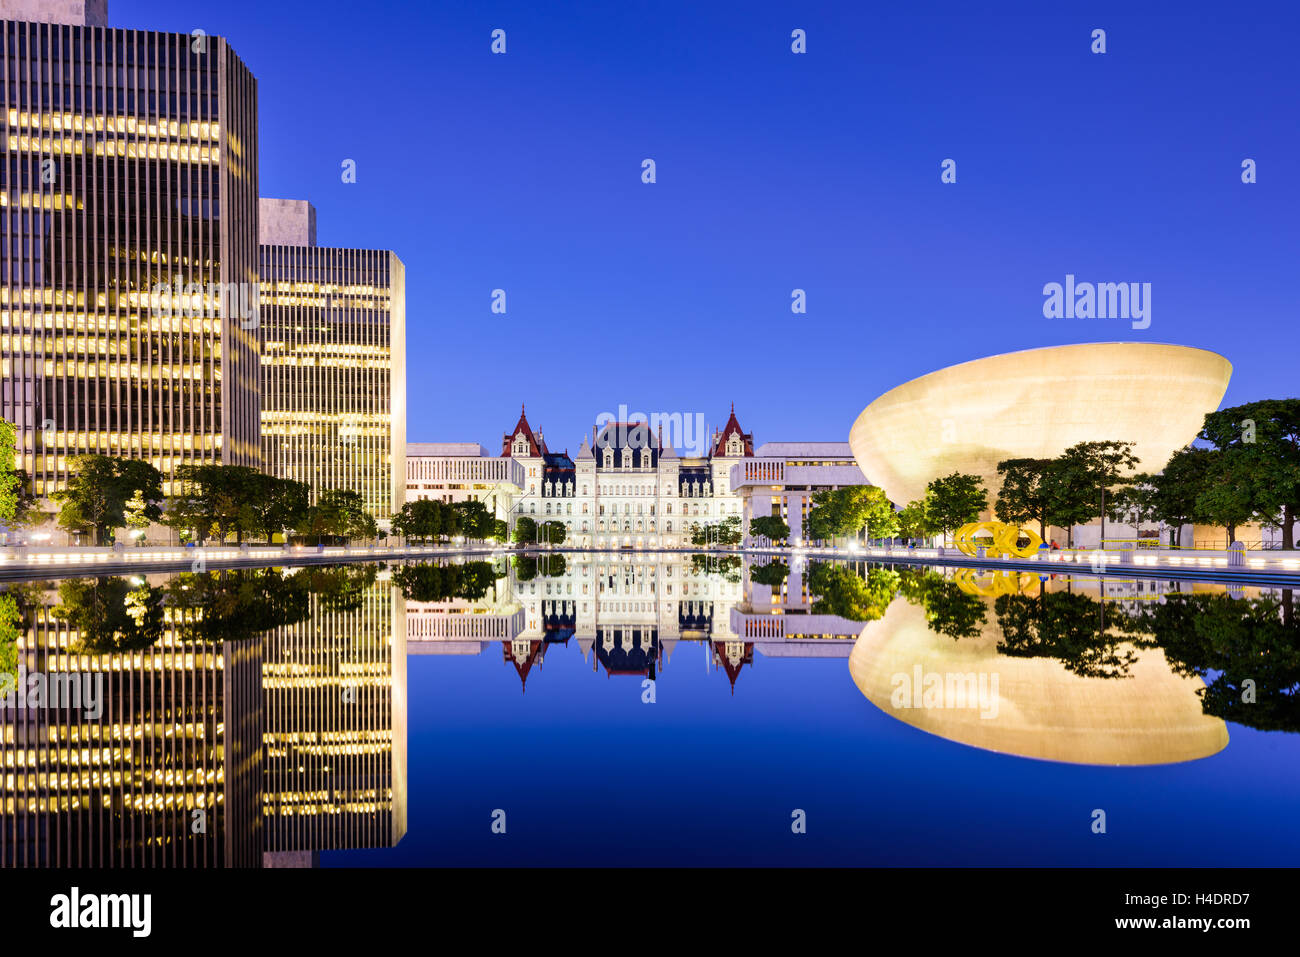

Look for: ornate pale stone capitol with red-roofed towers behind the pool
[406,407,867,549]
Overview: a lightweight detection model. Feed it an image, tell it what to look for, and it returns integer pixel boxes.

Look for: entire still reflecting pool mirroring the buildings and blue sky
[0,553,1300,867]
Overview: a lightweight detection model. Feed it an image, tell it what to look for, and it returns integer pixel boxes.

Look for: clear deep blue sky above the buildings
[119,0,1300,450]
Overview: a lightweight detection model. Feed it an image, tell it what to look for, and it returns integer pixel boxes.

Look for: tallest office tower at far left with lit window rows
[0,0,261,509]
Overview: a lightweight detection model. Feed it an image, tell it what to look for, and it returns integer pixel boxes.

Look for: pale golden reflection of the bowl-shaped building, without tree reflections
[849,599,1229,766]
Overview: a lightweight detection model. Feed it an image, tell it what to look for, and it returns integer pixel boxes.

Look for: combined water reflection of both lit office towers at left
[0,566,406,867]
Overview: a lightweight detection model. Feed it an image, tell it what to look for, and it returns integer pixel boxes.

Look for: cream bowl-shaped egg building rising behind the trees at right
[849,342,1232,505]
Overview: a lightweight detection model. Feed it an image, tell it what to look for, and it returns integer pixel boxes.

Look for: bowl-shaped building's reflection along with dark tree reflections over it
[849,573,1229,765]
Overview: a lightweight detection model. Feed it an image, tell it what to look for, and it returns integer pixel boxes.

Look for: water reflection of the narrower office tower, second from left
[261,566,407,856]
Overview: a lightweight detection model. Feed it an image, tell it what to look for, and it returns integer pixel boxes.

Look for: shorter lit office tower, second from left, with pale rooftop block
[260,199,407,521]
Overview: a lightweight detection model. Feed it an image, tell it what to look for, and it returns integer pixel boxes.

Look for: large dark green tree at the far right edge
[1200,399,1300,549]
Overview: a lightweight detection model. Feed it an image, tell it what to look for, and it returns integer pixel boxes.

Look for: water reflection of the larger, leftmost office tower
[0,577,264,867]
